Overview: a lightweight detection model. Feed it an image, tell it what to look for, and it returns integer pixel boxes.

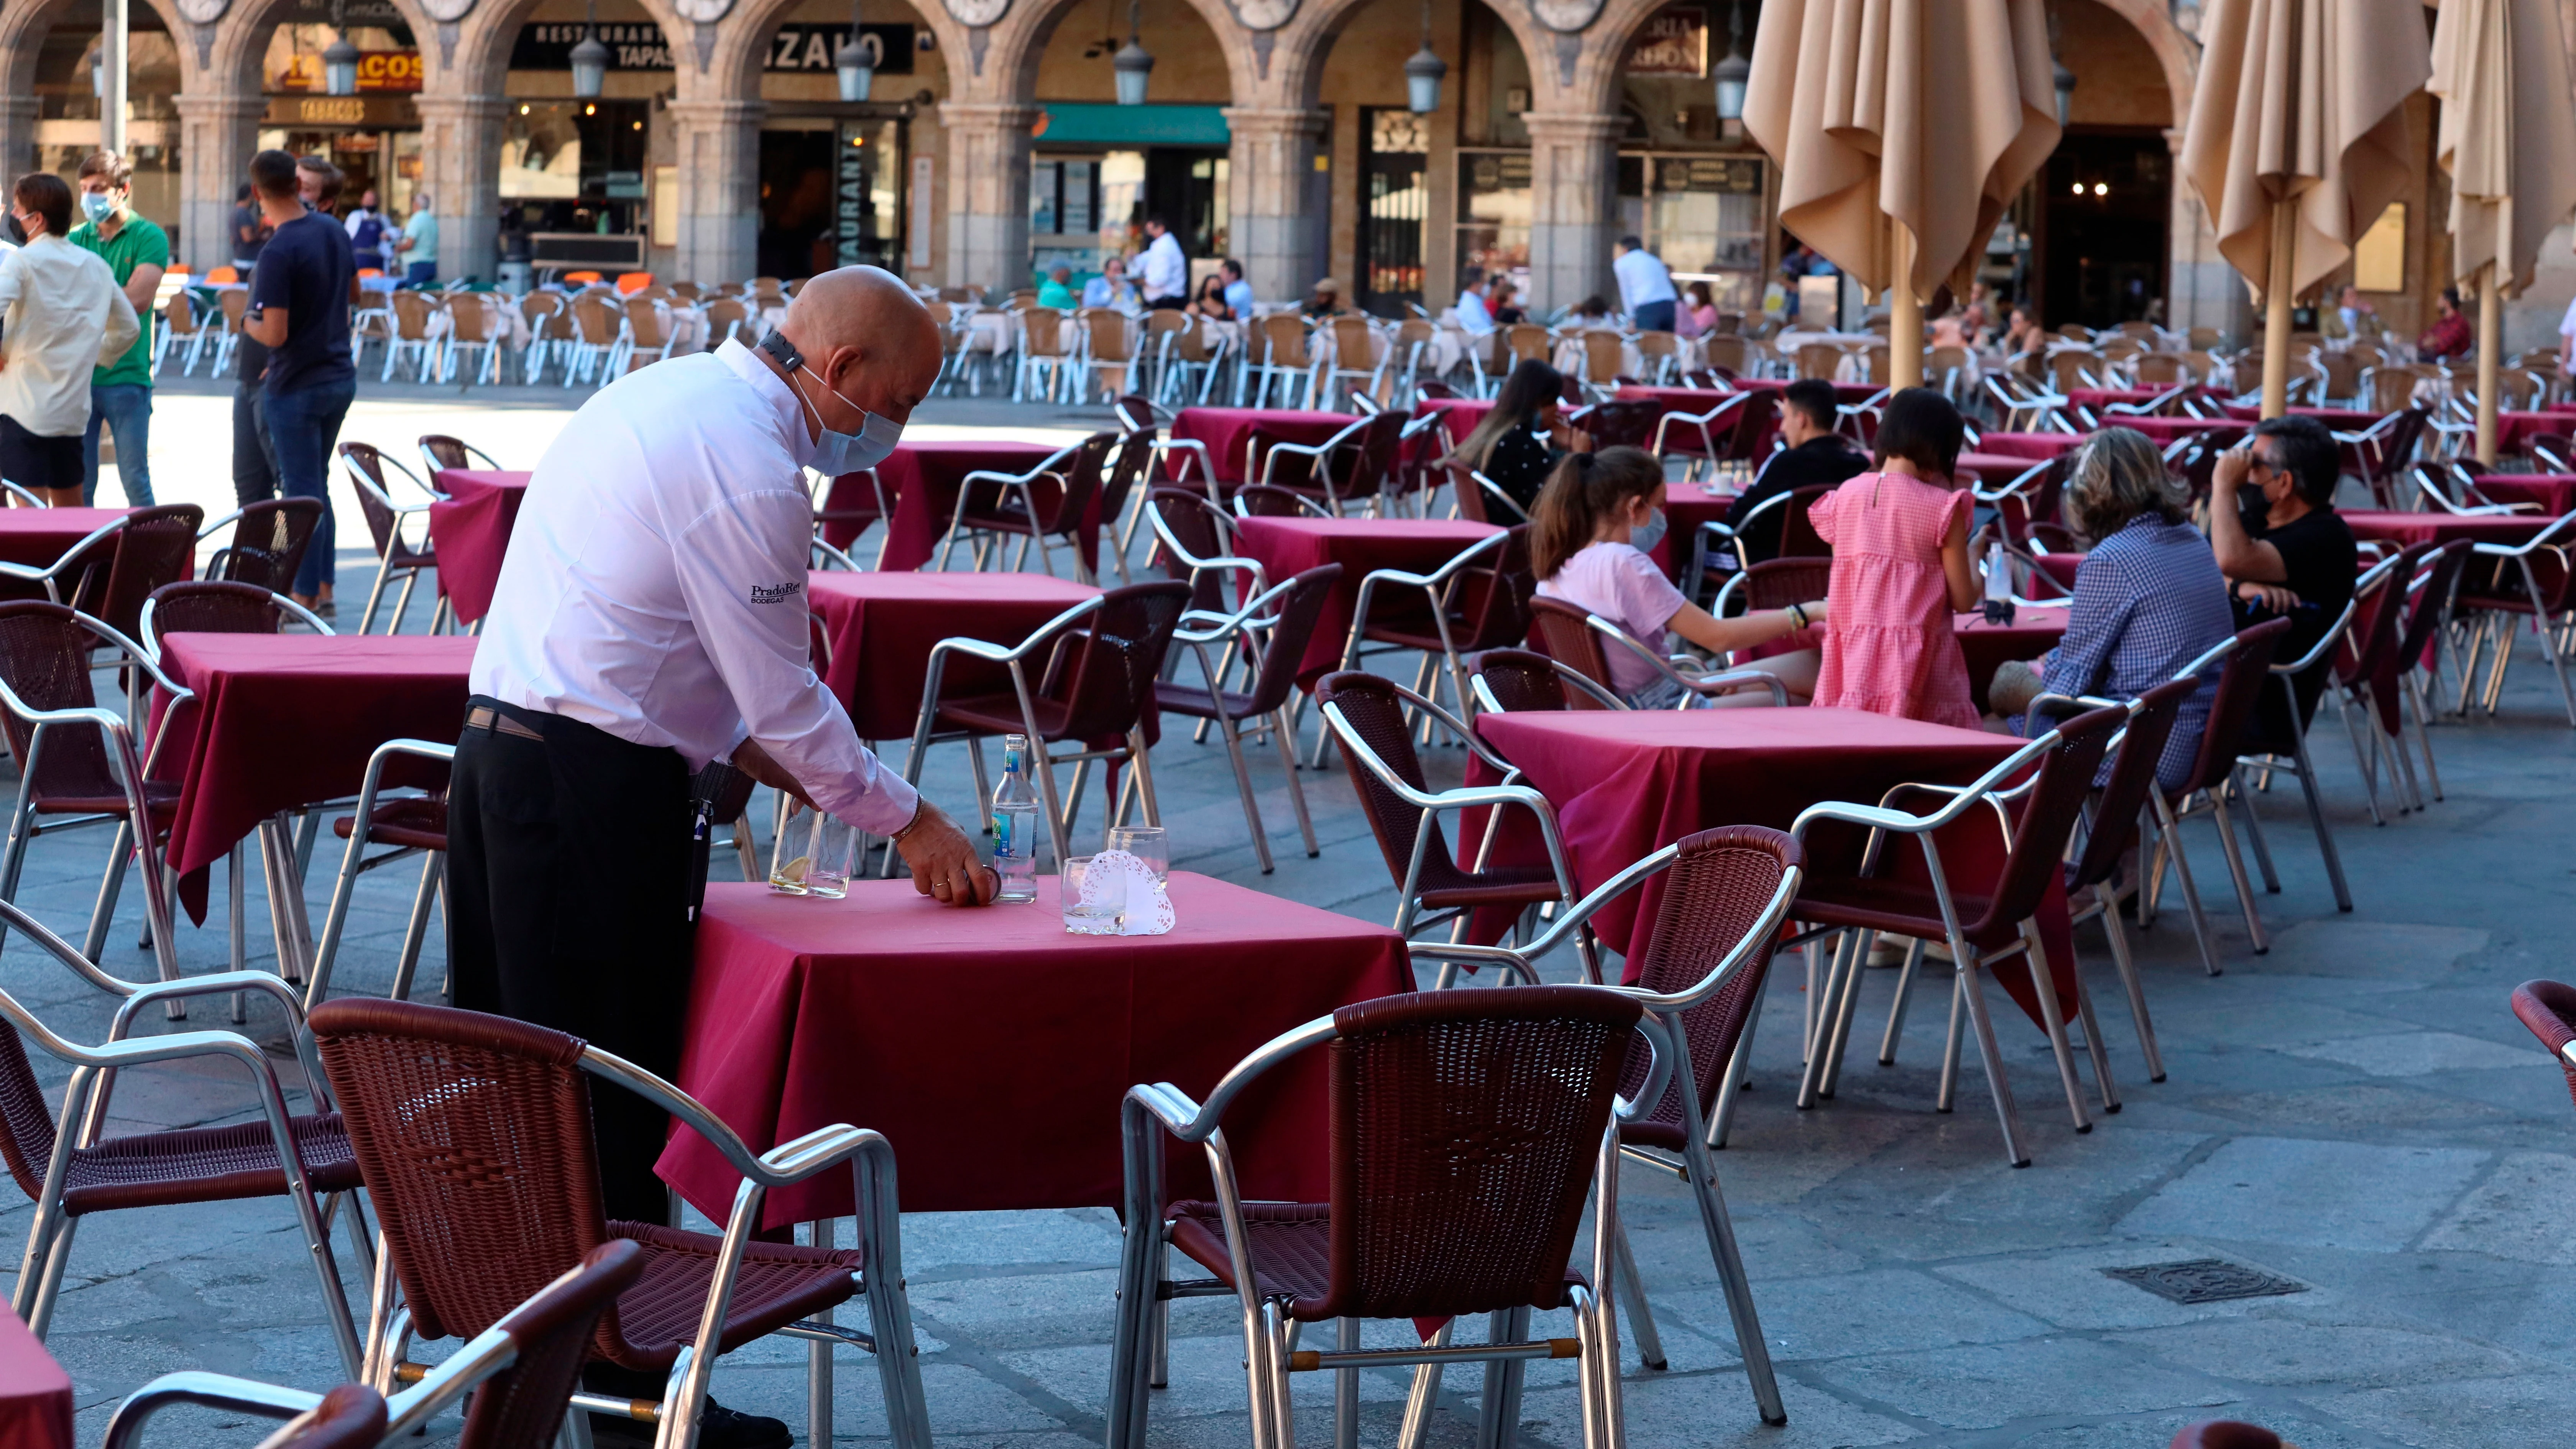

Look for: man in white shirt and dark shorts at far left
[0,170,142,508]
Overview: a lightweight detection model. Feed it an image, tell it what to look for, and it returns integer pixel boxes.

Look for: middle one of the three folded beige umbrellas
[2182,0,2432,418]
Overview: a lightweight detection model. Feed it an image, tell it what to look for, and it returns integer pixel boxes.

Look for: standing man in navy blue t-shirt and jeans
[242,152,358,616]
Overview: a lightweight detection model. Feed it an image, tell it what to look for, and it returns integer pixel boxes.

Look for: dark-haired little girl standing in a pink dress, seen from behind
[1808,387,1986,729]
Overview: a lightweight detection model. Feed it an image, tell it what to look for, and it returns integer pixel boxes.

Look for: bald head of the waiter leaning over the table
[773,266,943,433]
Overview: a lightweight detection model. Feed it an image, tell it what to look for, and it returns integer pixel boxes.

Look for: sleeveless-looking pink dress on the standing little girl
[1808,472,1978,729]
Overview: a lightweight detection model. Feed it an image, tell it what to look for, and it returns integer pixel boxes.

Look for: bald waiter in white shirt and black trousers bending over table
[448,266,997,1222]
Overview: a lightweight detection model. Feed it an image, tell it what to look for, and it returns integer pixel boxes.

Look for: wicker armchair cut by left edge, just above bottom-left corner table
[0,897,368,1377]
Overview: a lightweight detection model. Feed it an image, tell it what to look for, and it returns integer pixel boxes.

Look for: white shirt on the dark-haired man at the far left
[0,235,144,438]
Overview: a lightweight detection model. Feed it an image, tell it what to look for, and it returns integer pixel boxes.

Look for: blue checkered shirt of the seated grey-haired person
[2043,513,2236,789]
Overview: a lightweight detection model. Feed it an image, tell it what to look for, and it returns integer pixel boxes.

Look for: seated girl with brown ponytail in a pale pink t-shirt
[1530,449,1824,709]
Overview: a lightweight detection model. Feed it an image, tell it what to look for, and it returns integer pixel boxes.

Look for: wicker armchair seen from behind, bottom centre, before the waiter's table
[1108,985,1672,1449]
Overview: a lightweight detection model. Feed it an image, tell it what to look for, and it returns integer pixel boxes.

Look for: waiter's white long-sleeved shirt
[469,343,917,835]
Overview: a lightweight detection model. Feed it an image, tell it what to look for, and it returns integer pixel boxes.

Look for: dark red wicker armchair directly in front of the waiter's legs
[309,998,930,1449]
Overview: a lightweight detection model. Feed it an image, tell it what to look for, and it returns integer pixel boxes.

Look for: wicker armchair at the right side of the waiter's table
[1412,825,1806,1423]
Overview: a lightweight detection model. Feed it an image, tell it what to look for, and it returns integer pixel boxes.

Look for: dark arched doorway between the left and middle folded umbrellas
[2038,127,2174,327]
